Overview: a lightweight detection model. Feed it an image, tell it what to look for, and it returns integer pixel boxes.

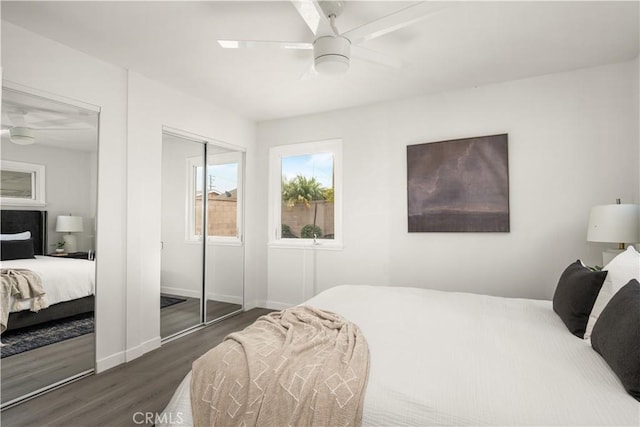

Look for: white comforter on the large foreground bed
[160,286,640,426]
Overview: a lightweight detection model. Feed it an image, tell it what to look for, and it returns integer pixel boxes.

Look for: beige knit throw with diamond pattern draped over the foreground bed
[191,306,369,427]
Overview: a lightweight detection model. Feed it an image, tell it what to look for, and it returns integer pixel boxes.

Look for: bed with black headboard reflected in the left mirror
[0,210,95,330]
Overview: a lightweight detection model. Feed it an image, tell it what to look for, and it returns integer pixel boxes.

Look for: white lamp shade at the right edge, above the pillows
[587,204,640,243]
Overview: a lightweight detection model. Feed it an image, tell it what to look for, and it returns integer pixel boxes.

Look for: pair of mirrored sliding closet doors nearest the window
[160,128,245,340]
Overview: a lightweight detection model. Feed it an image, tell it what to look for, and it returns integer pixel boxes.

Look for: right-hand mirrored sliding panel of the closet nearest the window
[206,142,244,322]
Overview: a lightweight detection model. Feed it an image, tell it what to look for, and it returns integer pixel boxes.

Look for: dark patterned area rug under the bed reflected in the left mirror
[0,313,93,357]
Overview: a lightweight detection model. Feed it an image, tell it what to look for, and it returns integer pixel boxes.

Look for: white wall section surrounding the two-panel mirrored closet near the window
[127,72,257,360]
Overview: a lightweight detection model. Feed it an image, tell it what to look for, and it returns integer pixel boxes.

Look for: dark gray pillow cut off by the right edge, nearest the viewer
[591,279,640,401]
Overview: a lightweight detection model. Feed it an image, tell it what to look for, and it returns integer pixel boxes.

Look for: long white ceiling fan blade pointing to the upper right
[342,2,451,44]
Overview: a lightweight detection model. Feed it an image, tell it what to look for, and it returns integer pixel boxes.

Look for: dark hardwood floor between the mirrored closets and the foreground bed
[0,309,271,427]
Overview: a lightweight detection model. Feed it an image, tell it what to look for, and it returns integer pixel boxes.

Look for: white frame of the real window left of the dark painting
[268,139,343,249]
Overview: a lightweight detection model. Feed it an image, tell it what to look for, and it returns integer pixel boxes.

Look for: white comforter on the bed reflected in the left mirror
[0,255,95,311]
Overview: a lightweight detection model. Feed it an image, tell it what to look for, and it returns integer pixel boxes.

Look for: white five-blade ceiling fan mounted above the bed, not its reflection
[218,0,438,74]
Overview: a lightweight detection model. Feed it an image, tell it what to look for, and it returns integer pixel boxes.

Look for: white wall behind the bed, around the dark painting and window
[258,61,640,308]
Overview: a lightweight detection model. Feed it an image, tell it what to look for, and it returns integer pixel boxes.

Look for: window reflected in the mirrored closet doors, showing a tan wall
[188,152,242,243]
